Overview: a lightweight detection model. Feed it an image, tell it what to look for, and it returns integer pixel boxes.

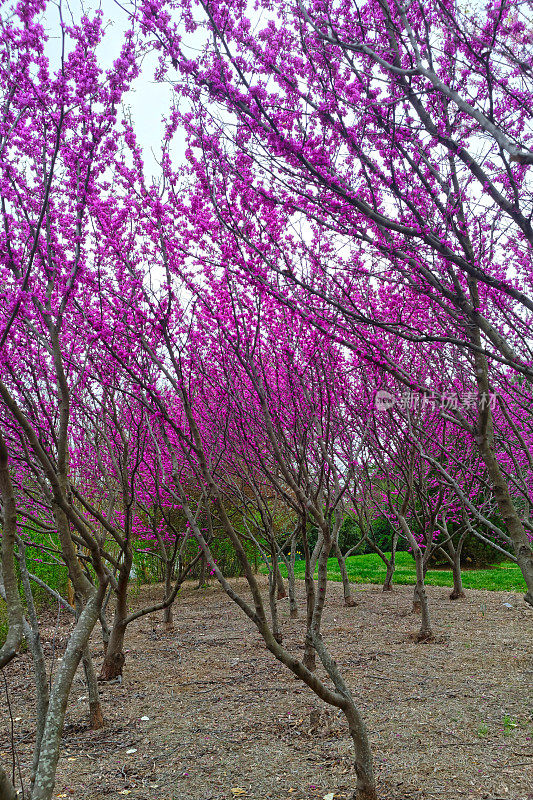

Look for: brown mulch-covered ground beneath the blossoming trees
[0,582,533,800]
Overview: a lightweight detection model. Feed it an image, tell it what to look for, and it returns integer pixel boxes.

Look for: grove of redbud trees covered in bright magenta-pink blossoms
[0,0,533,800]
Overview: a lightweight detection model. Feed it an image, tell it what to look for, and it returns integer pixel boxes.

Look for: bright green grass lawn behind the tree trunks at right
[280,552,526,592]
